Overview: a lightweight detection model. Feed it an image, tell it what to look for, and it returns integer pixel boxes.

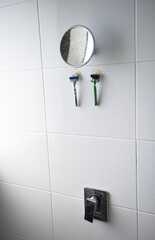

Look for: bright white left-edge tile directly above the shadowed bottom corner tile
[0,132,50,190]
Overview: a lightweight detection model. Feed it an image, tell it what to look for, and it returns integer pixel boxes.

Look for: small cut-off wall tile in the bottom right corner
[139,213,155,240]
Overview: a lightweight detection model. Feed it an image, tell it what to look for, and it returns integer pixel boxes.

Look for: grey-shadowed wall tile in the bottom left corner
[1,183,53,240]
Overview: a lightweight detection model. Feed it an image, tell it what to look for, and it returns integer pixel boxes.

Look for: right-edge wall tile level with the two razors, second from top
[137,63,155,140]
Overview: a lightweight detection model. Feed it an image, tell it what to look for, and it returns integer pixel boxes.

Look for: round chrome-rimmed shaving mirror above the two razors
[60,25,95,67]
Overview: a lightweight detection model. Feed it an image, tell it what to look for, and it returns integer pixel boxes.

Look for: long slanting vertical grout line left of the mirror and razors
[36,0,55,239]
